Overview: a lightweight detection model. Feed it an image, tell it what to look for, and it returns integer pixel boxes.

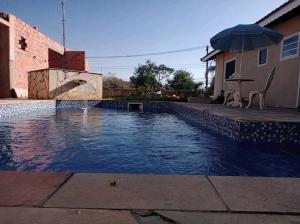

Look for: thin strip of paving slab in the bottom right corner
[157,211,300,224]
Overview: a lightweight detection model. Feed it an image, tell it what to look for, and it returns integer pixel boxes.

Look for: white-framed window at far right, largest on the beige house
[281,34,299,59]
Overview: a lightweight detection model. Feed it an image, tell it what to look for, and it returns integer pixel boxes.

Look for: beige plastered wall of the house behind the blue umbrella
[214,15,300,108]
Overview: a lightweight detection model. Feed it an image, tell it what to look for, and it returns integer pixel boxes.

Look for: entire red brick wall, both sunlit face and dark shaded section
[10,15,87,96]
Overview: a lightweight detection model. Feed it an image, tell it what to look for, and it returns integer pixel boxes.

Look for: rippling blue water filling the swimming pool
[0,108,300,177]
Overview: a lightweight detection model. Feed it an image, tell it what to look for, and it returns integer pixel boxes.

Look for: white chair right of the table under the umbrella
[247,67,276,110]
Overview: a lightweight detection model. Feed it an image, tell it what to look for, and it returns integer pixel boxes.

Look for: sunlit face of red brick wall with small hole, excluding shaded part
[10,15,63,91]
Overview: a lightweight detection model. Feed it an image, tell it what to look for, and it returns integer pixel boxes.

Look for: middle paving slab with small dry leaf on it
[45,174,225,211]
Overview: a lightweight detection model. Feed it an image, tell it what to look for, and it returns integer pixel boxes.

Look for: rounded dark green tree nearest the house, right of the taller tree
[168,70,202,91]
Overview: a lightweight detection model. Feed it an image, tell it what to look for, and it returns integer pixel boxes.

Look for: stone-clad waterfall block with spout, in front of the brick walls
[28,69,102,100]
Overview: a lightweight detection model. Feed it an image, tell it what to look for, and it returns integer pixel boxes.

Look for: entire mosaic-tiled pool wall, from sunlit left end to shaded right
[0,100,300,145]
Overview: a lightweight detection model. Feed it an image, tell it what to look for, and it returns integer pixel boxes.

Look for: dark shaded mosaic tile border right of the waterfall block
[98,100,300,144]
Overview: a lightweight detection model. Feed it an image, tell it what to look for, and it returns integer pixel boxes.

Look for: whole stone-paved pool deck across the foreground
[0,172,300,224]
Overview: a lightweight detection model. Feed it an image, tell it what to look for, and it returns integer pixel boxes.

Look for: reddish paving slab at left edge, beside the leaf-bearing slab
[0,172,71,206]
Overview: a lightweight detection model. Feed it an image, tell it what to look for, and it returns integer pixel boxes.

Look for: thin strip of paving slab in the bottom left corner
[0,208,137,224]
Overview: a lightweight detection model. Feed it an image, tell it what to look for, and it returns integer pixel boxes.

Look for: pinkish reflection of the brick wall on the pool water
[1,111,65,171]
